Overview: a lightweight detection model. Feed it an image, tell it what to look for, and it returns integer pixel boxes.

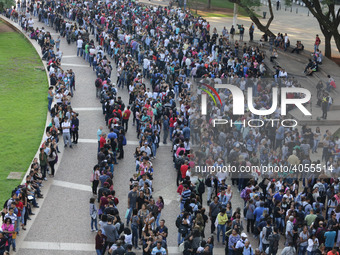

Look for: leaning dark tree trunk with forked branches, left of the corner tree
[229,0,274,36]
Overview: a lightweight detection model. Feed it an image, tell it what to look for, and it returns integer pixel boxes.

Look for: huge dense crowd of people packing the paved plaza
[0,1,340,255]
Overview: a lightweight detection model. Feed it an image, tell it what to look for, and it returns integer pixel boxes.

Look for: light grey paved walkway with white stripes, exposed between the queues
[7,13,195,255]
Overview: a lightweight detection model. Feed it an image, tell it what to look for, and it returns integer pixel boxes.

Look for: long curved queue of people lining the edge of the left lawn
[0,6,79,254]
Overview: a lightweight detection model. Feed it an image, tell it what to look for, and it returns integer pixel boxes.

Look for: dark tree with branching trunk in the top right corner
[302,0,340,58]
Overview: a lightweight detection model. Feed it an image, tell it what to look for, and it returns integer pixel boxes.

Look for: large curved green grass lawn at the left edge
[0,22,48,208]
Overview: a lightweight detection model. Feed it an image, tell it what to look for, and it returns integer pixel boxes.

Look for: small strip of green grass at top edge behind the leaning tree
[188,0,248,17]
